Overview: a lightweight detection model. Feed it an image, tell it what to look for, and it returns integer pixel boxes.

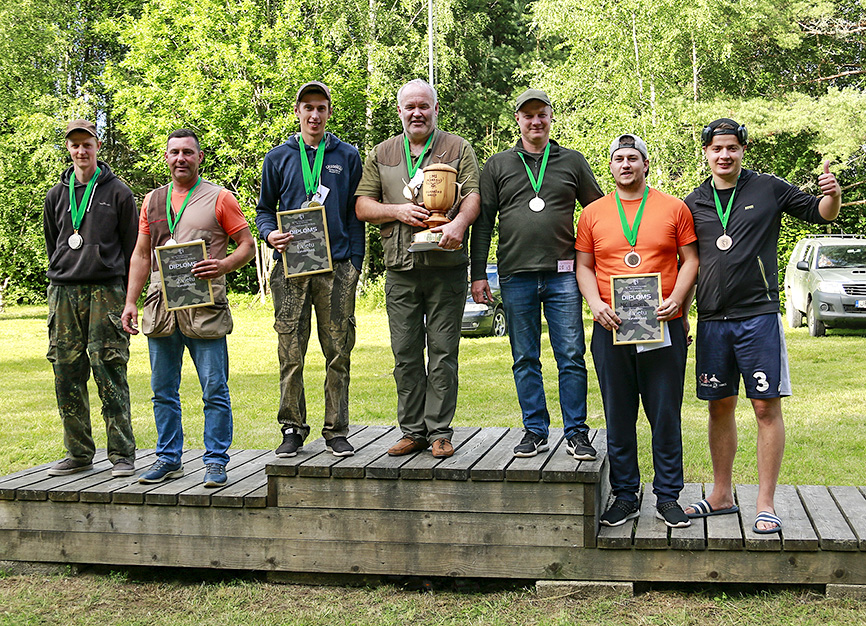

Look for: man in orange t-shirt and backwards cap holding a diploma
[575,134,698,528]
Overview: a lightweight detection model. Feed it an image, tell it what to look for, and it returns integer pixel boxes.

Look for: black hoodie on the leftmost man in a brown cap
[42,161,138,285]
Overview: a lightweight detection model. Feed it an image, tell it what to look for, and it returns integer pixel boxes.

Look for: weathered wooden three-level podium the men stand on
[0,426,866,585]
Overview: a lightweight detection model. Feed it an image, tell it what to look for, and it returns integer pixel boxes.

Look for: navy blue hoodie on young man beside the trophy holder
[256,133,364,269]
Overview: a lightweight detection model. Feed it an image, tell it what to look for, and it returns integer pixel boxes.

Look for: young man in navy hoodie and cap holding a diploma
[256,81,364,457]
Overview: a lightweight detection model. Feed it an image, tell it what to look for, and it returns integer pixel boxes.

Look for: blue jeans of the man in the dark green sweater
[499,272,589,438]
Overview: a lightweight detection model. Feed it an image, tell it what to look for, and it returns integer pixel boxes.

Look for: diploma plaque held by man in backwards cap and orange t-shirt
[610,272,665,345]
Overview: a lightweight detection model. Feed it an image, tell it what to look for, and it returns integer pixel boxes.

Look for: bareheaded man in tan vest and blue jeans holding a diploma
[121,128,255,487]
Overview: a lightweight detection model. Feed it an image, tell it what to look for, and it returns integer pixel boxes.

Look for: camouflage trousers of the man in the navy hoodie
[271,261,359,439]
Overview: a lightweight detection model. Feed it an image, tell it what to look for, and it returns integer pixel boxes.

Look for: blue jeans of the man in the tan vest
[147,330,232,465]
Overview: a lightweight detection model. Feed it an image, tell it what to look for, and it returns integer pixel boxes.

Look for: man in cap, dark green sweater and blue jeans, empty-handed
[470,89,602,460]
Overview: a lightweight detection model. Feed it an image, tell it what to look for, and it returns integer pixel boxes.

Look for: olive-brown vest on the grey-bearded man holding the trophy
[376,129,469,271]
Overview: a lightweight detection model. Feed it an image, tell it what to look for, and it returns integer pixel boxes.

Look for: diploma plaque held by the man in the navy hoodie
[277,205,333,278]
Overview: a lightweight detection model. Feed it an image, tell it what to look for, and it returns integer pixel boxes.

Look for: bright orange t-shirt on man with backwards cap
[574,188,698,306]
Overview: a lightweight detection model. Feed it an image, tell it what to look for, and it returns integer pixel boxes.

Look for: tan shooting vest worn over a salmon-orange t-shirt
[141,180,232,339]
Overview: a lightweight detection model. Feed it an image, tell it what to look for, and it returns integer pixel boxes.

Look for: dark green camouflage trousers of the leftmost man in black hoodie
[47,284,135,463]
